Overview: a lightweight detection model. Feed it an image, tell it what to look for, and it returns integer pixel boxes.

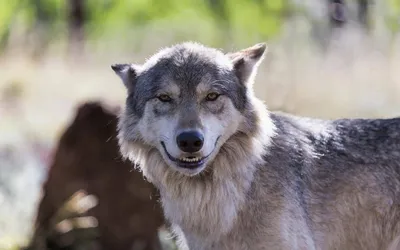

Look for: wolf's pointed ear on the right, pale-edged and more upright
[227,43,267,85]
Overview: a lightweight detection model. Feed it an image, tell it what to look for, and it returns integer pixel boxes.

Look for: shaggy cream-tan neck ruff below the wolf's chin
[156,104,274,240]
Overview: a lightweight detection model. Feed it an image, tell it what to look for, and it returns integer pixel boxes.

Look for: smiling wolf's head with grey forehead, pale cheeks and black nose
[112,43,266,176]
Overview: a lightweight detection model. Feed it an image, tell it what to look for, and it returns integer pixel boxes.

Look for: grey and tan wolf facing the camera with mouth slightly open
[111,42,400,250]
